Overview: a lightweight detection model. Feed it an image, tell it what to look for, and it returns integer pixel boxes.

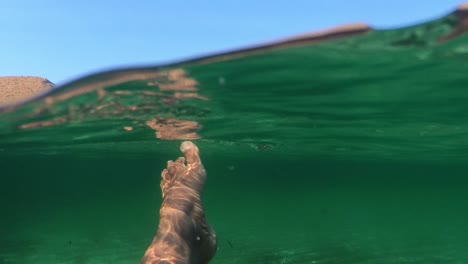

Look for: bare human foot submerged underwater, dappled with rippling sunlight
[141,141,217,264]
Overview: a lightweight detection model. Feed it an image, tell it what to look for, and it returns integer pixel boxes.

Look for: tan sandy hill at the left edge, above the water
[0,76,54,104]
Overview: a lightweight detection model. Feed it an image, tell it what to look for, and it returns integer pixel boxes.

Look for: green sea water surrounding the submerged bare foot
[0,14,468,264]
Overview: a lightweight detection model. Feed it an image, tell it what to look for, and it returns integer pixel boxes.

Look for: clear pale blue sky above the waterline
[0,0,462,83]
